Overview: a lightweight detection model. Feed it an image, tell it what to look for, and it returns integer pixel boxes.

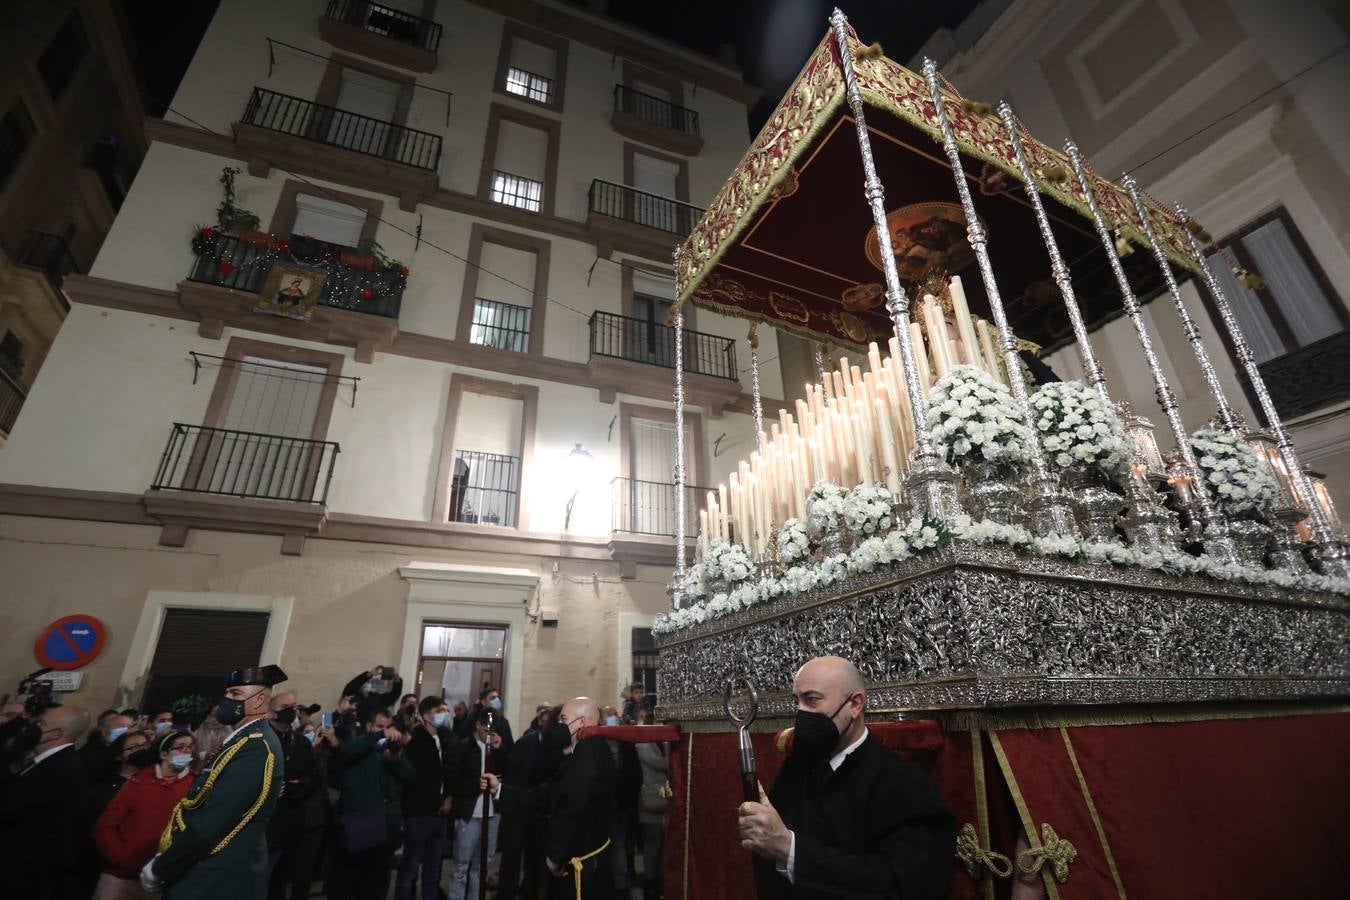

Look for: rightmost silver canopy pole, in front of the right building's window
[1176,204,1350,578]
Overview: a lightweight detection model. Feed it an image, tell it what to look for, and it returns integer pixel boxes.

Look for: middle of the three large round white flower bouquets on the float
[1031,382,1134,479]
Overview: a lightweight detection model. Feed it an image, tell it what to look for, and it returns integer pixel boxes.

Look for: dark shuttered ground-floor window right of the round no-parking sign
[140,607,270,710]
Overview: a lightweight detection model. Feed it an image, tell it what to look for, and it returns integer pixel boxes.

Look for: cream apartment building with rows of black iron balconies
[0,0,783,721]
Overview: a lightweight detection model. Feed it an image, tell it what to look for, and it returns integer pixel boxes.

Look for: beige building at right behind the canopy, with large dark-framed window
[911,0,1350,513]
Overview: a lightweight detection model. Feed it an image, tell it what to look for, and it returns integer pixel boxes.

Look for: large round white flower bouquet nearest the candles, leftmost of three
[923,364,1031,470]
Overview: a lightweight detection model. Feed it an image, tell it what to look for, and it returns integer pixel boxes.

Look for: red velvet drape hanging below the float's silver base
[666,712,1350,900]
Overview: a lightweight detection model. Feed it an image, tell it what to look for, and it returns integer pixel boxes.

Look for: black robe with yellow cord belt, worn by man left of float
[500,737,618,900]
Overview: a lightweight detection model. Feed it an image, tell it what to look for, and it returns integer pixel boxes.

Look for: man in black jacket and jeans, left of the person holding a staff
[394,696,454,900]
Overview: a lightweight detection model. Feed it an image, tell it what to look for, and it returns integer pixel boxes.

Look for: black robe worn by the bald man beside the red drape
[756,735,956,900]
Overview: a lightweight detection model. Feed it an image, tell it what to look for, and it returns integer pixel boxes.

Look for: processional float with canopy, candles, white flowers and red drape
[655,11,1350,897]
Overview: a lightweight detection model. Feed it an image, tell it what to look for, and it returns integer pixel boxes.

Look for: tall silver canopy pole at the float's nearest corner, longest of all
[830,9,961,521]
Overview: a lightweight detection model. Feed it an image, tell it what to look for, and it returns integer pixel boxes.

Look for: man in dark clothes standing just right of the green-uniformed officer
[267,691,324,900]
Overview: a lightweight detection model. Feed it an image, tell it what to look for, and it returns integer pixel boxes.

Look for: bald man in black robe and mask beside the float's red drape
[740,656,956,900]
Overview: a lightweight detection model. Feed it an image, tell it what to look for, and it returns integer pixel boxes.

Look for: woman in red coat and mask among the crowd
[93,731,193,900]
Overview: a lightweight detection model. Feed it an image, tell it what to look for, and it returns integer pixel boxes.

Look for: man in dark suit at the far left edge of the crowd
[0,706,89,900]
